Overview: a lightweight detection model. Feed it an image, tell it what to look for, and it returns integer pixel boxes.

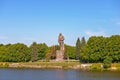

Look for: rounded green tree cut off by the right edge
[106,35,120,62]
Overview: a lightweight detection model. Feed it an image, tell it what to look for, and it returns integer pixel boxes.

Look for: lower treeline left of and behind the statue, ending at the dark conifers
[0,42,75,62]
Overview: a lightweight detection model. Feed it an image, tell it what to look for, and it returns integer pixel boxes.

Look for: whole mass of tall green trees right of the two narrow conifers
[80,35,120,63]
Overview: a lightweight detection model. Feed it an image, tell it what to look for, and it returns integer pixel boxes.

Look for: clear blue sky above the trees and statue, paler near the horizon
[0,0,120,45]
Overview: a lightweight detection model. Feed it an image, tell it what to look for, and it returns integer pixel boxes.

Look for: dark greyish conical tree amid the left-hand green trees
[30,42,38,61]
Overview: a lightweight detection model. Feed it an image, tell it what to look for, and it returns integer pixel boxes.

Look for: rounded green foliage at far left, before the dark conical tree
[0,43,31,62]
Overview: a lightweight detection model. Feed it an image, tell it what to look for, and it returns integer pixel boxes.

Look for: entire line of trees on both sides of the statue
[0,35,120,63]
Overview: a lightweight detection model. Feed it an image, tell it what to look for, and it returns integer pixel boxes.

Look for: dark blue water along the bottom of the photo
[0,68,120,80]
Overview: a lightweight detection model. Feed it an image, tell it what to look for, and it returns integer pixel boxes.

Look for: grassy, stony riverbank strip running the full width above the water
[0,62,120,71]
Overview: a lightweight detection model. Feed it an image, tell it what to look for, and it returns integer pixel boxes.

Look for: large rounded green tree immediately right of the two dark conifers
[81,36,106,62]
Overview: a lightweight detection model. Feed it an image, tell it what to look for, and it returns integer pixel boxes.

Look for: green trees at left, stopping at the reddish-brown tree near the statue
[0,42,48,62]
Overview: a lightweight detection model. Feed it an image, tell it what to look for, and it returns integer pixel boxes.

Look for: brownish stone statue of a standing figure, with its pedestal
[56,33,64,61]
